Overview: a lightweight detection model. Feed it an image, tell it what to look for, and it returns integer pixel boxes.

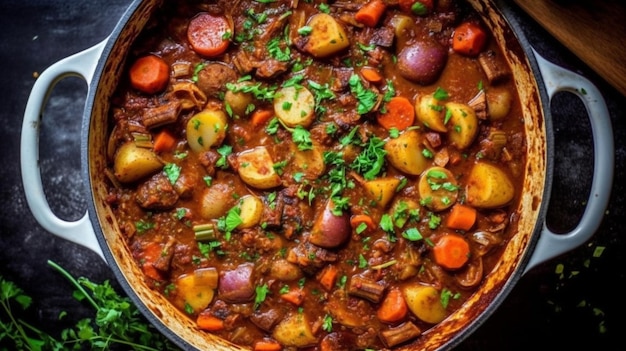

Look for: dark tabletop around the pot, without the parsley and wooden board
[0,0,626,350]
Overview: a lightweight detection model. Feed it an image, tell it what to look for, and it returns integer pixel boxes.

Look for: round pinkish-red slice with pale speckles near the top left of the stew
[187,12,232,57]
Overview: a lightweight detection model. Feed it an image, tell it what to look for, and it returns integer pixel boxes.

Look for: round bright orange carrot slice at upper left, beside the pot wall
[129,55,170,94]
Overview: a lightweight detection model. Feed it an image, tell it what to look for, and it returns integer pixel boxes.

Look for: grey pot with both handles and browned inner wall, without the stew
[21,0,614,350]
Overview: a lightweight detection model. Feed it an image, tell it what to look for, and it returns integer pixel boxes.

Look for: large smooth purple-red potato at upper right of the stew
[398,40,448,85]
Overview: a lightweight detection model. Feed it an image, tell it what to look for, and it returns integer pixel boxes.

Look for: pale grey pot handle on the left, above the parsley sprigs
[20,40,107,261]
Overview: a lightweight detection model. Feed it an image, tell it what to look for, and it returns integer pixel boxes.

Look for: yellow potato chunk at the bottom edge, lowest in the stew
[272,313,317,347]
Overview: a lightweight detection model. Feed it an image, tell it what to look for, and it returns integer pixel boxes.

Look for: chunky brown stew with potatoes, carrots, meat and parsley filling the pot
[106,0,526,351]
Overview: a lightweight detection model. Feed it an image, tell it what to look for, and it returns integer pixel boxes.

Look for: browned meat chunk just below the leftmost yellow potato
[135,172,179,210]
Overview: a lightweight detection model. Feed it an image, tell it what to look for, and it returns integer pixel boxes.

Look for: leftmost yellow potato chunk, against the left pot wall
[113,141,164,183]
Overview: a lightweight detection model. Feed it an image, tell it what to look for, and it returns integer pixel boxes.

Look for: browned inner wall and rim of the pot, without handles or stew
[83,0,548,350]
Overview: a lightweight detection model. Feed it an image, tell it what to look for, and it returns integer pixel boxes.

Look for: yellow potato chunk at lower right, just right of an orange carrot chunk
[402,284,447,324]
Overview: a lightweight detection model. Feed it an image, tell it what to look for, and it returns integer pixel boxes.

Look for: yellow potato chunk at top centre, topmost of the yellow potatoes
[303,13,350,57]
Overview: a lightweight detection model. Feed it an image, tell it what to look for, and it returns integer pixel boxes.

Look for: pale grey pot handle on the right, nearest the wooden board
[524,50,615,273]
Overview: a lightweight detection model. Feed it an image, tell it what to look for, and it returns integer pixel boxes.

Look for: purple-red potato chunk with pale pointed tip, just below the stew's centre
[309,200,352,249]
